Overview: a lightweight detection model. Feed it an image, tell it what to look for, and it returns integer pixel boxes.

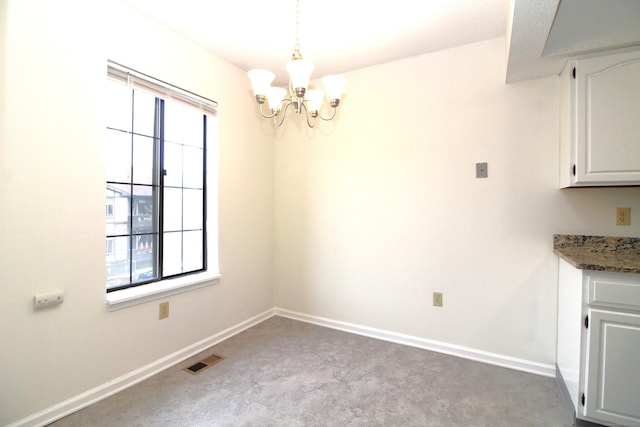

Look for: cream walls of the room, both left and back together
[0,0,640,425]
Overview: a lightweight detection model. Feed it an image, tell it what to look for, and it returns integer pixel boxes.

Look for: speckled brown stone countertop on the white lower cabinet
[553,234,640,273]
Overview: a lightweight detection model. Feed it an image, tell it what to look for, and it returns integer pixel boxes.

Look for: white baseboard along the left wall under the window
[7,309,275,427]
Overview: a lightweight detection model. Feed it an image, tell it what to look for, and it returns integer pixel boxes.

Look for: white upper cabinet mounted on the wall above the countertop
[560,50,640,187]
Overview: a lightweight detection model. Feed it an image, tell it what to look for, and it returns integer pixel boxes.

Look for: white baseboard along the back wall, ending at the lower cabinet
[275,307,556,378]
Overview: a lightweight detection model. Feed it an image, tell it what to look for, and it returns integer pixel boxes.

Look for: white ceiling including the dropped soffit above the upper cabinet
[121,0,640,84]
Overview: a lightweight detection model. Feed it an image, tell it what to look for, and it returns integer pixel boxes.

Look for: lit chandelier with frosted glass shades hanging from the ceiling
[247,0,346,128]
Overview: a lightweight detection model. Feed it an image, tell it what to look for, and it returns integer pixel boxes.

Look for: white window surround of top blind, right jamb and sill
[105,61,220,311]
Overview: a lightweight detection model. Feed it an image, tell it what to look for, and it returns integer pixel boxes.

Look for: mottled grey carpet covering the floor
[53,317,571,427]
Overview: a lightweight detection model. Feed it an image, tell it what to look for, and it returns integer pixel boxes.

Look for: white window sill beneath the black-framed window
[107,272,220,311]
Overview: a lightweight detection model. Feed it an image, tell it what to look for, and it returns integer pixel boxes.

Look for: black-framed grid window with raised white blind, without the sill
[104,64,215,292]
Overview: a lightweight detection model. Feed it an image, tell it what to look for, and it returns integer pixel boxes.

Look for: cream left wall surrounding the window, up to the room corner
[0,0,273,425]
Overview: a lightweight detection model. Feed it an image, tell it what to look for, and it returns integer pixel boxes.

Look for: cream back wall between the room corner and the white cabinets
[275,39,640,364]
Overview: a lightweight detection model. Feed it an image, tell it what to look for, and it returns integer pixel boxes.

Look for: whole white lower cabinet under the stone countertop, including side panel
[557,259,640,426]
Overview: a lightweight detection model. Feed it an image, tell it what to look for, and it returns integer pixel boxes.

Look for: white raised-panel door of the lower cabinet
[583,309,640,425]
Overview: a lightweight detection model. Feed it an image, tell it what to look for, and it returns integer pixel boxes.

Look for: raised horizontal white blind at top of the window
[107,61,218,112]
